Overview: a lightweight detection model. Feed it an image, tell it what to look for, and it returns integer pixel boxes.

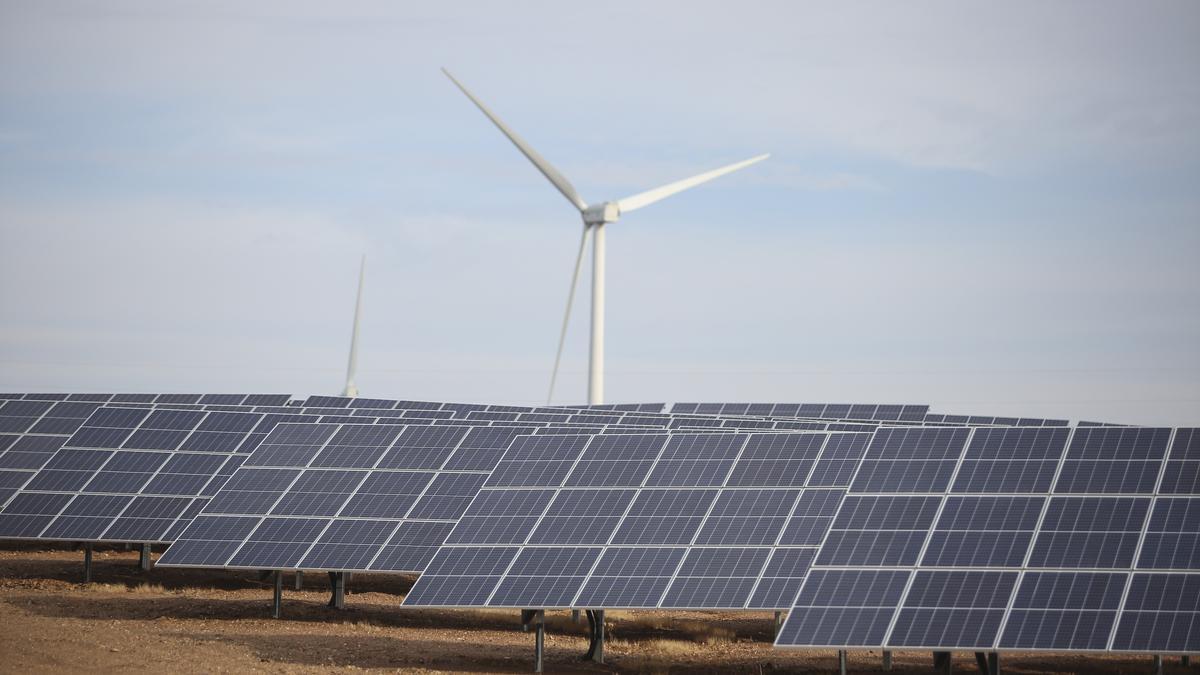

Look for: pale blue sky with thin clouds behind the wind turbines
[0,0,1200,425]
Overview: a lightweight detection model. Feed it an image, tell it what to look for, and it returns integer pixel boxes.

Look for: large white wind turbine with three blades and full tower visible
[442,68,770,406]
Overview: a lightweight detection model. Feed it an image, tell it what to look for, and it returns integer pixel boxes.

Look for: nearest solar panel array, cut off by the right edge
[776,426,1200,652]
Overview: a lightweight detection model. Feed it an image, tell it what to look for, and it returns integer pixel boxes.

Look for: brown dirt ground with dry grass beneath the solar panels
[0,546,1194,674]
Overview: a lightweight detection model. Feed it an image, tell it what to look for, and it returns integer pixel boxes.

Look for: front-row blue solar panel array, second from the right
[404,432,868,609]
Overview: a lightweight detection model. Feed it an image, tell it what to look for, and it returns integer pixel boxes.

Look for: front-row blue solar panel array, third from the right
[158,424,533,572]
